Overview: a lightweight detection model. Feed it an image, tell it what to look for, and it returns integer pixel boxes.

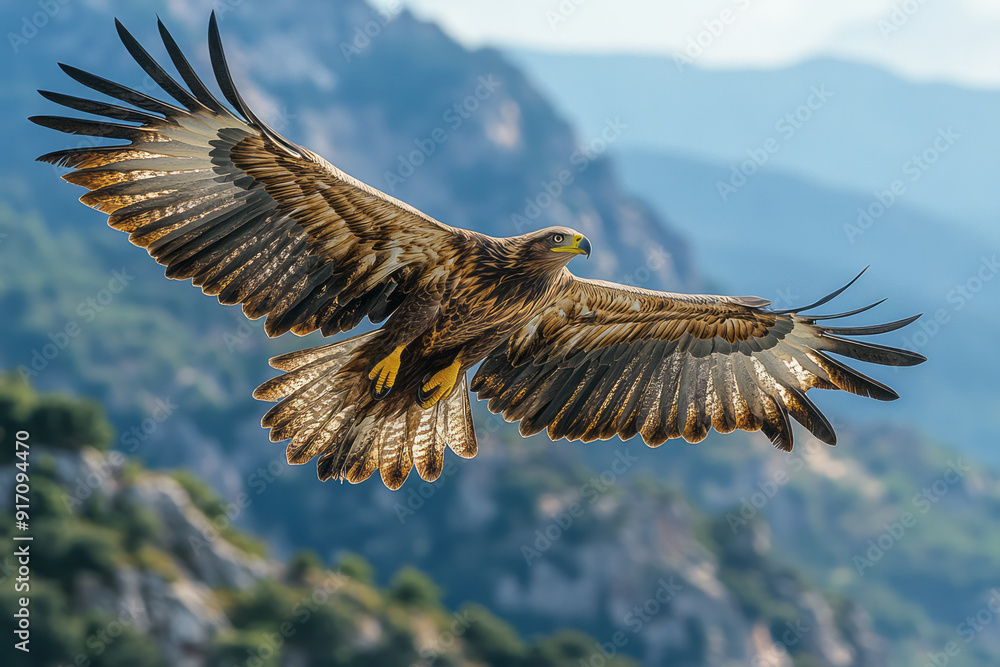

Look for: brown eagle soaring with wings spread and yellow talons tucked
[30,13,925,489]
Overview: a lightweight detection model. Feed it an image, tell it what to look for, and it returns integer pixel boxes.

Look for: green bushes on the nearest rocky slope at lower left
[0,381,635,667]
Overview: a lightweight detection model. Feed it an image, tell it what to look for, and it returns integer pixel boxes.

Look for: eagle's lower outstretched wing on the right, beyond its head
[471,271,925,451]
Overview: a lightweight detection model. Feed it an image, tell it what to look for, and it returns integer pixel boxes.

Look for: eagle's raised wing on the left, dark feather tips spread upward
[31,13,470,336]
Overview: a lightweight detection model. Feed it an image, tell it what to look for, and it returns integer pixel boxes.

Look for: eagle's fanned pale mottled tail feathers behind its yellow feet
[253,332,477,489]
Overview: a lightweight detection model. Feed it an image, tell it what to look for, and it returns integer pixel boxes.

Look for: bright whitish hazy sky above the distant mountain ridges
[384,0,1000,87]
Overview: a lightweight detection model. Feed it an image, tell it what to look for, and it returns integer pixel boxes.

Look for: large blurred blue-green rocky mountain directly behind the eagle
[0,0,1000,667]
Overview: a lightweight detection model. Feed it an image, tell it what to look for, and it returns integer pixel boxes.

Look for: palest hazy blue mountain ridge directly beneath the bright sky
[507,50,1000,237]
